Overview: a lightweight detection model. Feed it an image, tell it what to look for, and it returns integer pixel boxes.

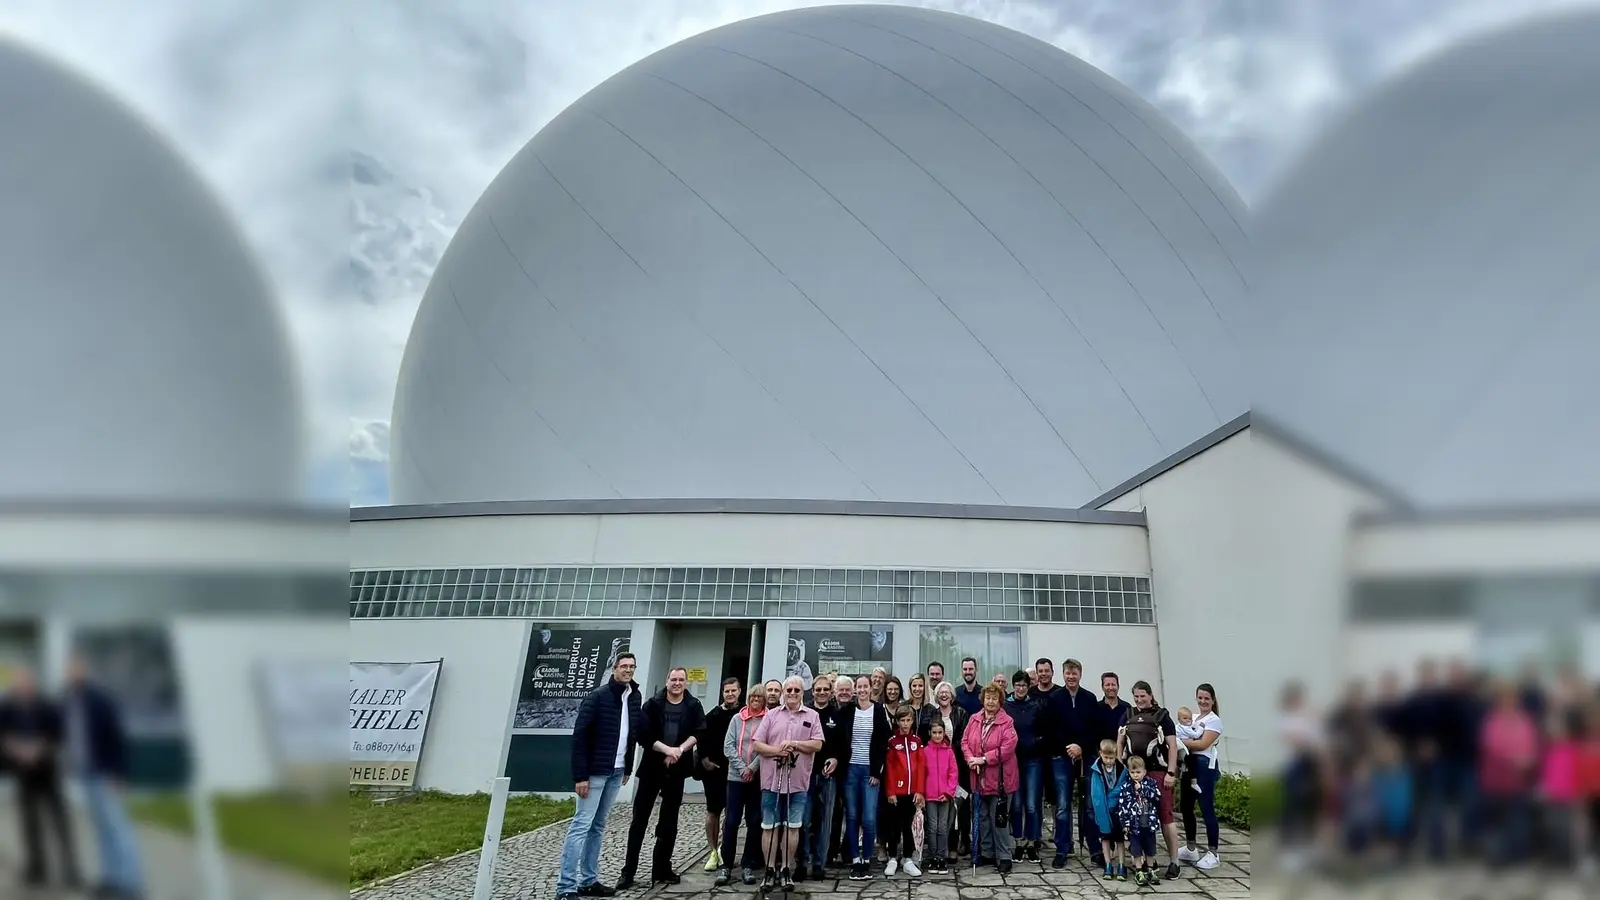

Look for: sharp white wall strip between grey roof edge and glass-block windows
[350,512,1149,575]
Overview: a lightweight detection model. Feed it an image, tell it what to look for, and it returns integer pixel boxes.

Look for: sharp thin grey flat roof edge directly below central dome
[350,498,1146,527]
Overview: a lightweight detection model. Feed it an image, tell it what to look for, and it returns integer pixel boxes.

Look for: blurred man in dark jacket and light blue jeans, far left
[62,655,144,898]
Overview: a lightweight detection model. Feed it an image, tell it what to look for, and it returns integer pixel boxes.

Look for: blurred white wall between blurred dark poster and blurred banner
[171,615,350,793]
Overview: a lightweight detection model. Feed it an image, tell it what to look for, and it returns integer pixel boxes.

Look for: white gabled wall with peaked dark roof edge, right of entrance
[1107,429,1378,767]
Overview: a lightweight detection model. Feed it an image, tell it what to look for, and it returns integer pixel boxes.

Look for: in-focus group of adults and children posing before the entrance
[557,653,1222,900]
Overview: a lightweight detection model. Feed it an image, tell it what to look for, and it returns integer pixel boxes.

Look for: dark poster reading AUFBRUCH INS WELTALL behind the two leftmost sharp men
[514,628,632,729]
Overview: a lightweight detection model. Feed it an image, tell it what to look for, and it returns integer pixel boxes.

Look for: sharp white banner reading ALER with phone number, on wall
[350,660,443,788]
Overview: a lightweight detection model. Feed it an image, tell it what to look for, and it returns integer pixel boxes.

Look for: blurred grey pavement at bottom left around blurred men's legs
[0,786,337,900]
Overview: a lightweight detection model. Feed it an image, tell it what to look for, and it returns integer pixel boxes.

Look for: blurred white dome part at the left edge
[0,38,304,503]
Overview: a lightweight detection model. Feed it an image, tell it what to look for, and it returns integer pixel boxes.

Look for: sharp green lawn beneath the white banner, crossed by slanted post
[349,791,573,887]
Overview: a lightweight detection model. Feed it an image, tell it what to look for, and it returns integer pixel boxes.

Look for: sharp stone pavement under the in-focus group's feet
[350,801,1250,900]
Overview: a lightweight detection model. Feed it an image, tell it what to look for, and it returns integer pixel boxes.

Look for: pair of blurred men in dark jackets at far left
[0,658,144,900]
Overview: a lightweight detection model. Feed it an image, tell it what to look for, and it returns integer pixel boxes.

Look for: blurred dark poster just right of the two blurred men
[72,625,184,738]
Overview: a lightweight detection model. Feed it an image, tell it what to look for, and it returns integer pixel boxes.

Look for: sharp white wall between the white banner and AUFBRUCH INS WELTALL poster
[349,618,531,794]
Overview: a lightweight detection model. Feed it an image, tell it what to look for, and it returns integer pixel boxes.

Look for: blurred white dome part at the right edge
[1238,11,1600,508]
